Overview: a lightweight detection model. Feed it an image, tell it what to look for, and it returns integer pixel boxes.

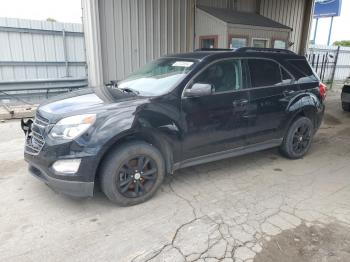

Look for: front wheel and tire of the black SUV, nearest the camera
[100,141,165,206]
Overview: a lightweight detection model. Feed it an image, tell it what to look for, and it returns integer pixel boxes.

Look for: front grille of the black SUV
[25,114,50,155]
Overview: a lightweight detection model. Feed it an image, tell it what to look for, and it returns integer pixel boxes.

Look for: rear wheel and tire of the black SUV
[280,117,314,159]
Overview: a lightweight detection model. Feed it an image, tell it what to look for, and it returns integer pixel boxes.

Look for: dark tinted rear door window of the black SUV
[247,59,282,87]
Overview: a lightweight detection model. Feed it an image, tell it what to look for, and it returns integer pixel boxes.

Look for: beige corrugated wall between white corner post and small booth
[99,0,193,83]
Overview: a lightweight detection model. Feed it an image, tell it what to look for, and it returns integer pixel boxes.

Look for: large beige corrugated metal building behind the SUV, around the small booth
[82,0,314,86]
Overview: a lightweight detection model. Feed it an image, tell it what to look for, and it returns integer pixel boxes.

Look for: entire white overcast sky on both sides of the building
[0,0,350,45]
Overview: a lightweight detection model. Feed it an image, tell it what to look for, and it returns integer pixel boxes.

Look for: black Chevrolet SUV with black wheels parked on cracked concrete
[22,48,326,205]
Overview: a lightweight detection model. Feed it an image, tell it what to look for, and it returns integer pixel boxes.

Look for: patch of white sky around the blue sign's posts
[310,0,350,45]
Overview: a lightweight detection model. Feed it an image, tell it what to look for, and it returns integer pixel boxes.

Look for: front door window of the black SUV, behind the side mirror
[194,59,242,93]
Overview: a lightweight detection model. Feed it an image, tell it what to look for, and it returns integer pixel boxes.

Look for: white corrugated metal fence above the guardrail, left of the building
[0,18,86,81]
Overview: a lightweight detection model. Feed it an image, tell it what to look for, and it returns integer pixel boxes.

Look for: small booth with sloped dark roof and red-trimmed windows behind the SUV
[195,6,292,49]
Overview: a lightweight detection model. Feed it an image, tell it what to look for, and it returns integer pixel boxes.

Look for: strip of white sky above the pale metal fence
[0,0,82,23]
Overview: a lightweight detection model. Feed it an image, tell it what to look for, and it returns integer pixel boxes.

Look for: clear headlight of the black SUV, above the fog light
[50,114,96,140]
